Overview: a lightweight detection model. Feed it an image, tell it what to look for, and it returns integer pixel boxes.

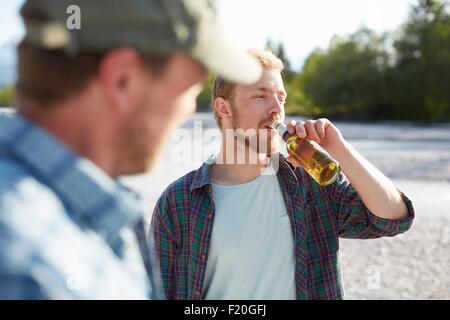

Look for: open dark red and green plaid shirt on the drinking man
[151,156,414,300]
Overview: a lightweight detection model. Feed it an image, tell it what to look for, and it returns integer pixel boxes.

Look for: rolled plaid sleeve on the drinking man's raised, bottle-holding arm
[326,173,415,239]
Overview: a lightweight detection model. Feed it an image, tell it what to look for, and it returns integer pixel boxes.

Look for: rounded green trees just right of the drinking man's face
[295,28,389,120]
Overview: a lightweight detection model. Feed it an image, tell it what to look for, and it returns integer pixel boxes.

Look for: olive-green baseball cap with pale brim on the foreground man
[22,0,262,84]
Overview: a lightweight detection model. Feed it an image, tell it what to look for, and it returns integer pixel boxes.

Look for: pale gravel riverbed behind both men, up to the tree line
[126,114,450,299]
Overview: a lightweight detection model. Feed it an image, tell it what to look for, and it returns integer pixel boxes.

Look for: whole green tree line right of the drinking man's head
[296,0,450,122]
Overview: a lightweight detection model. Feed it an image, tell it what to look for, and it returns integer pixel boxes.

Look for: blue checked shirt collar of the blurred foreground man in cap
[0,115,142,250]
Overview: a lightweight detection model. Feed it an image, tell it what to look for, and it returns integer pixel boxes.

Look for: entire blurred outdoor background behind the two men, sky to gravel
[0,0,450,299]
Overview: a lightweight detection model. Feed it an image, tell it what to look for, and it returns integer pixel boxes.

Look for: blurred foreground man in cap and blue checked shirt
[0,0,261,299]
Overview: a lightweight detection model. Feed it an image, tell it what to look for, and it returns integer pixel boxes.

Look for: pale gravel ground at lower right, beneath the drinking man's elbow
[340,180,450,299]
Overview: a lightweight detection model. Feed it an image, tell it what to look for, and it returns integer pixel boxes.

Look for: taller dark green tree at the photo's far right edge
[390,0,450,122]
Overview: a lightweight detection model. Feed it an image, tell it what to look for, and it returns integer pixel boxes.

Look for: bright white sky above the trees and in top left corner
[0,0,415,70]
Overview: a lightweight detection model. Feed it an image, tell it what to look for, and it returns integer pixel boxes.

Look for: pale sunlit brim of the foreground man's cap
[192,24,262,85]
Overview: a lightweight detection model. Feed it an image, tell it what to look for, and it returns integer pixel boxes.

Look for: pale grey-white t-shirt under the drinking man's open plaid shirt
[204,166,296,300]
